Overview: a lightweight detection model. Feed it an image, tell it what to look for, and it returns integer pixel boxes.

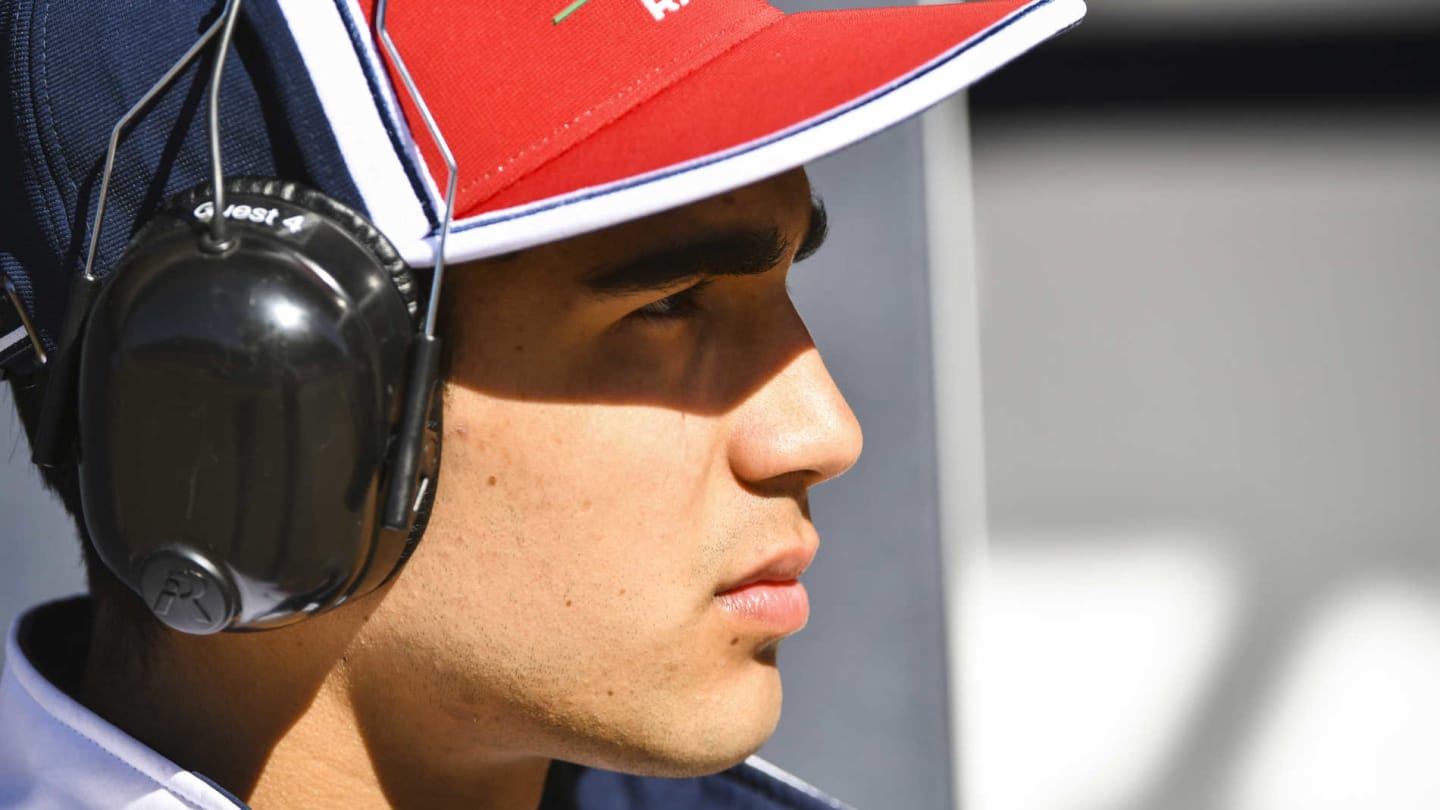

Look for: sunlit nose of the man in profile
[730,336,863,490]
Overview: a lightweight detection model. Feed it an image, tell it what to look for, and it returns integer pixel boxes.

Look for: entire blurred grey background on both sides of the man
[8,0,1440,810]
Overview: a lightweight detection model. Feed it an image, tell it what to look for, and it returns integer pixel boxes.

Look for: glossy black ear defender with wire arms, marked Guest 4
[35,0,456,634]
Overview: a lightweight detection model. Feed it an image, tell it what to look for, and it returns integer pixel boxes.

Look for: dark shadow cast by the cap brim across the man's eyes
[442,172,831,415]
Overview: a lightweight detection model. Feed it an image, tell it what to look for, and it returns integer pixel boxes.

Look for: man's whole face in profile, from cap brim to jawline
[347,172,861,775]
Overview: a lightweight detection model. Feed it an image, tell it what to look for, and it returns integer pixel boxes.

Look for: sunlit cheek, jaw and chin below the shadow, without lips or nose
[360,380,779,773]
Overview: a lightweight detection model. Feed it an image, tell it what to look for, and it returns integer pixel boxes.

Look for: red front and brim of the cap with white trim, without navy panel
[279,0,1084,265]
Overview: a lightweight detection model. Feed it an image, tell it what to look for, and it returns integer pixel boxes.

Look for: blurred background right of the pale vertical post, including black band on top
[942,0,1440,810]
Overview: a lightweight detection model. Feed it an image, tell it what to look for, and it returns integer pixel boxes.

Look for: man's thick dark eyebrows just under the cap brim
[585,197,828,295]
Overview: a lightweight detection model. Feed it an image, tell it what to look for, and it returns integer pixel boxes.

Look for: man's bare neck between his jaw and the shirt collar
[81,593,549,810]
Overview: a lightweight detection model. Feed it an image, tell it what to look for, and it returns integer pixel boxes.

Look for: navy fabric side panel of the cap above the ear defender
[0,0,364,353]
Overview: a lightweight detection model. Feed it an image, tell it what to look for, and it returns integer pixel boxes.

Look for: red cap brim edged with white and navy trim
[321,0,1086,267]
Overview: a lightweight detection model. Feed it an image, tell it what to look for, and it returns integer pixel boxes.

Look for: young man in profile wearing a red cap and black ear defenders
[0,0,1083,809]
